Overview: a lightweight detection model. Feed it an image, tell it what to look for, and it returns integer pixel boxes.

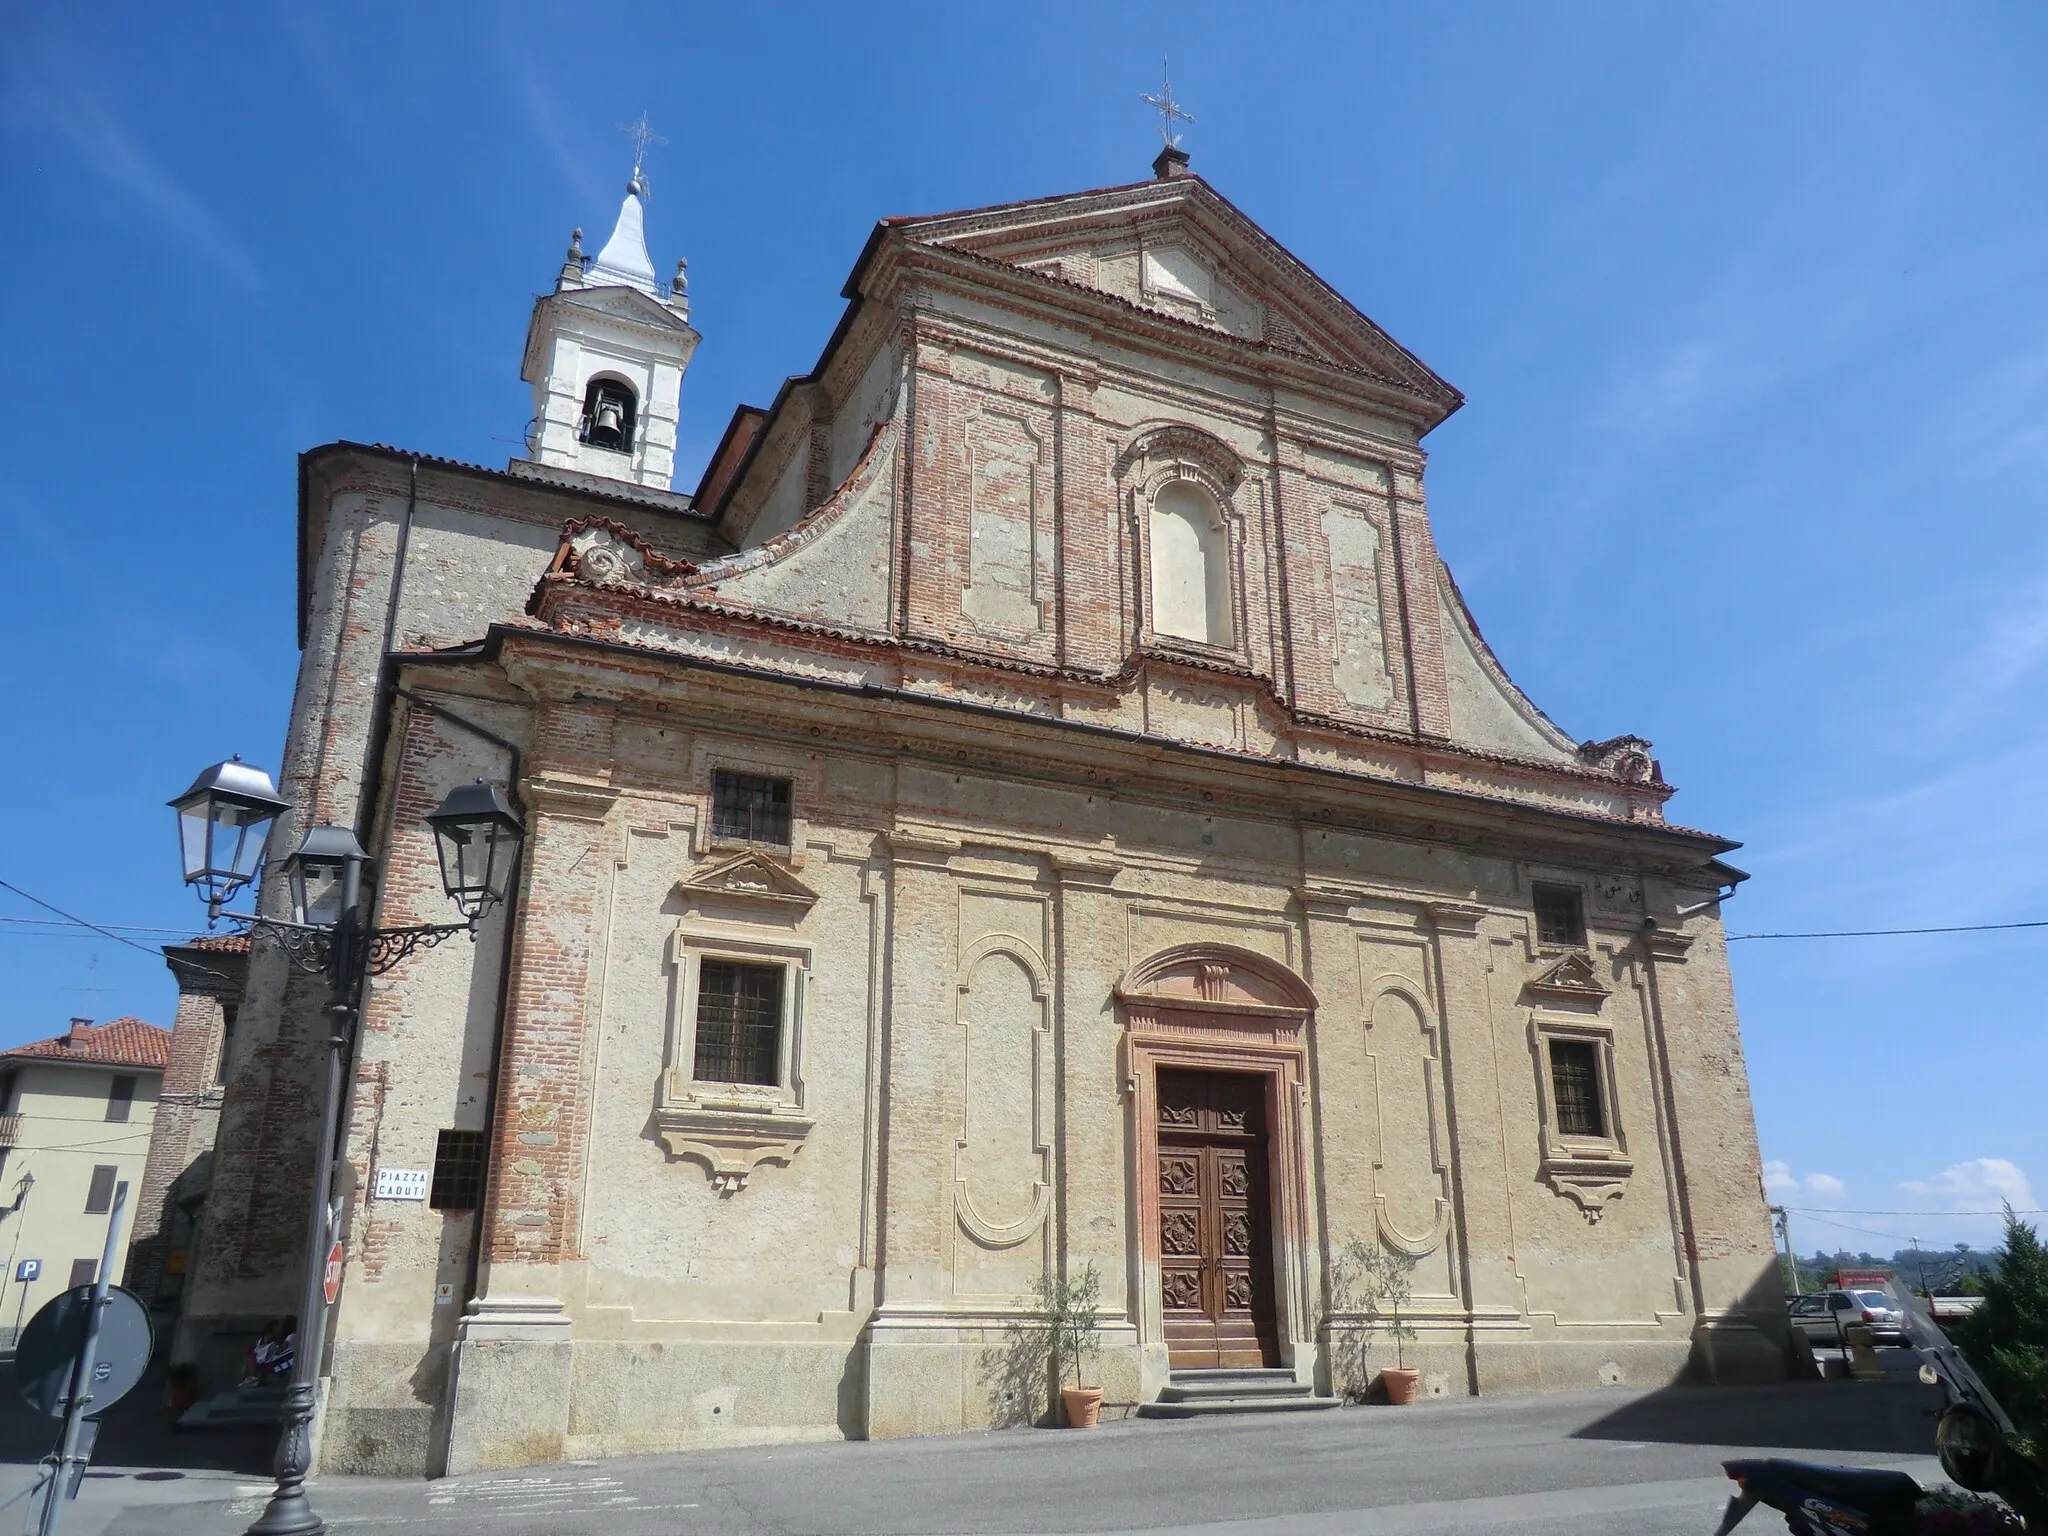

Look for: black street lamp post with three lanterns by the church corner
[170,758,524,1536]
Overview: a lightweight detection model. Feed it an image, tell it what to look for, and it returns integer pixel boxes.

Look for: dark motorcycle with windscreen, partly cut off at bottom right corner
[1714,1296,2048,1536]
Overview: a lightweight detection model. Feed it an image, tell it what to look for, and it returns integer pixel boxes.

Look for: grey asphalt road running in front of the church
[0,1352,1937,1536]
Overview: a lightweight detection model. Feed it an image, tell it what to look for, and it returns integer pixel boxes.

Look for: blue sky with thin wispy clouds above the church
[0,0,2048,1249]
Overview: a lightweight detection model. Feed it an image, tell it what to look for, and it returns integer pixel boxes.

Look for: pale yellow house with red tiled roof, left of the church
[0,1018,170,1343]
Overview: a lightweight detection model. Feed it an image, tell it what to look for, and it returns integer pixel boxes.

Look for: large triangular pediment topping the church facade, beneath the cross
[893,176,1460,414]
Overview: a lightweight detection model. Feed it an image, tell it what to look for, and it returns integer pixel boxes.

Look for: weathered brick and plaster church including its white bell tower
[176,150,1784,1473]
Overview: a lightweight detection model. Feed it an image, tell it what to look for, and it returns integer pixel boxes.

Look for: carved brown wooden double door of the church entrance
[1157,1069,1280,1370]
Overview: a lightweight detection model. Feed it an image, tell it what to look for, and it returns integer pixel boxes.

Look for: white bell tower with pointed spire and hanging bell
[520,137,698,492]
